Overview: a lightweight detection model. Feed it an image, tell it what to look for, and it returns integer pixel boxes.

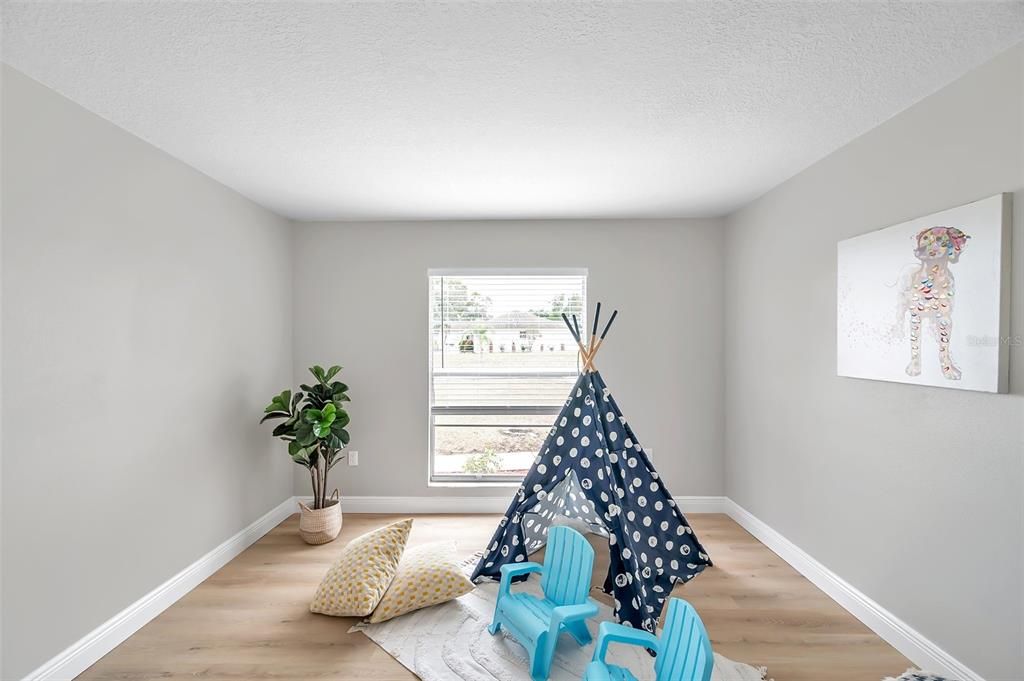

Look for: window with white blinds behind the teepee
[429,269,587,482]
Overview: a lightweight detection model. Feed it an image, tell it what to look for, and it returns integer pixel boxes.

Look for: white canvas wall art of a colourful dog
[837,194,1013,392]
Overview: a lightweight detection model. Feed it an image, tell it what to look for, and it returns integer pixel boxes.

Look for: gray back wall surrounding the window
[294,220,724,496]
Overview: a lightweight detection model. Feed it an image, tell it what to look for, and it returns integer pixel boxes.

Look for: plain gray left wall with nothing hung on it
[0,67,293,679]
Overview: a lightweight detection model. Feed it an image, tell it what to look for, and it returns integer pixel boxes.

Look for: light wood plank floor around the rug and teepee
[79,515,910,681]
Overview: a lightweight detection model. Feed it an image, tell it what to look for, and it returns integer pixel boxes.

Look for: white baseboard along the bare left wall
[25,497,296,681]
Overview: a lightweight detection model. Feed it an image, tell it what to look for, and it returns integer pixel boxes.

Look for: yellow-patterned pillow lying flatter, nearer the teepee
[370,542,473,623]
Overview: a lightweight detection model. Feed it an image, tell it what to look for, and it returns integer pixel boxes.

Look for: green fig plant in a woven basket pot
[260,366,349,544]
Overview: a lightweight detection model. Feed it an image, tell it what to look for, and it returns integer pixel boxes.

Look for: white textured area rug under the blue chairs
[351,580,766,681]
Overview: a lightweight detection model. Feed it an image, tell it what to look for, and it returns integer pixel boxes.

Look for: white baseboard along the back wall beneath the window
[327,491,727,513]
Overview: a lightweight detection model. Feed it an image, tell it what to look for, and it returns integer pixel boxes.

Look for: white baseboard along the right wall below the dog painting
[726,499,984,681]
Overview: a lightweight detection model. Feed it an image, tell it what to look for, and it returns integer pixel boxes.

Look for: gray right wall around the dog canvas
[725,48,1024,679]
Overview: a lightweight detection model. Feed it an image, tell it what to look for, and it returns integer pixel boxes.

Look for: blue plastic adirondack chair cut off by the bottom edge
[583,598,715,681]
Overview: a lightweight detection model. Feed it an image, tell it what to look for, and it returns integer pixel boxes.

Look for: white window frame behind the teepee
[427,267,590,487]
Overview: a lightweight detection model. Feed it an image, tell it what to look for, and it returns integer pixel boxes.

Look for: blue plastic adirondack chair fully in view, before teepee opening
[487,525,597,681]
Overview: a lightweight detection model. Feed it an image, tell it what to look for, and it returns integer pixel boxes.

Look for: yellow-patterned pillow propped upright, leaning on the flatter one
[309,518,413,618]
